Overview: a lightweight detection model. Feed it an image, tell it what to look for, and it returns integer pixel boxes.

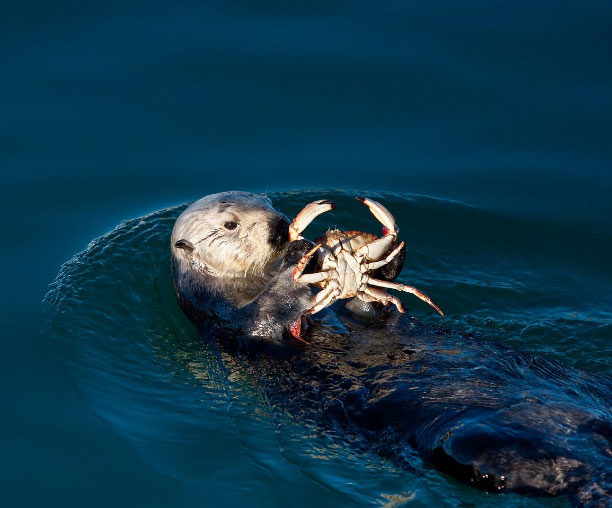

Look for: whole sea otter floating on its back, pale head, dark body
[171,192,612,506]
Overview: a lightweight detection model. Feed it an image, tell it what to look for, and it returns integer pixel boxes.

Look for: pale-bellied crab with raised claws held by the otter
[289,197,444,316]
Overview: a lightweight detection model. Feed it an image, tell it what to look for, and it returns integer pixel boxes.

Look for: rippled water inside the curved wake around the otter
[45,191,612,506]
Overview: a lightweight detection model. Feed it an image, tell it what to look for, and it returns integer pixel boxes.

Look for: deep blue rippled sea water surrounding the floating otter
[0,0,612,507]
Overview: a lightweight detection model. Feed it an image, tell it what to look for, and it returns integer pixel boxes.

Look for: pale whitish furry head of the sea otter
[172,192,289,277]
